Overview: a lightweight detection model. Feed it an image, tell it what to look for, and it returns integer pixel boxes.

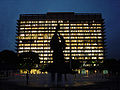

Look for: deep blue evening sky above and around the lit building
[0,0,120,59]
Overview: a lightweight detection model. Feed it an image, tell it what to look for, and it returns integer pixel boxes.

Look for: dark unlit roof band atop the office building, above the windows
[20,12,102,20]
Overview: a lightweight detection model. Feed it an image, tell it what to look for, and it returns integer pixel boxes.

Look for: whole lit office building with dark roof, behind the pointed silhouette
[16,12,105,66]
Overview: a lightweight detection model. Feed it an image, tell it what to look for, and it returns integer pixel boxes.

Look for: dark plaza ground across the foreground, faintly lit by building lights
[0,74,120,90]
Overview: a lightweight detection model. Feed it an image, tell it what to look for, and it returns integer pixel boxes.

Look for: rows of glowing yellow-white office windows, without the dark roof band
[18,13,105,66]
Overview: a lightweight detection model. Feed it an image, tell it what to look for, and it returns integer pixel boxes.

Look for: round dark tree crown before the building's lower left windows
[19,52,40,70]
